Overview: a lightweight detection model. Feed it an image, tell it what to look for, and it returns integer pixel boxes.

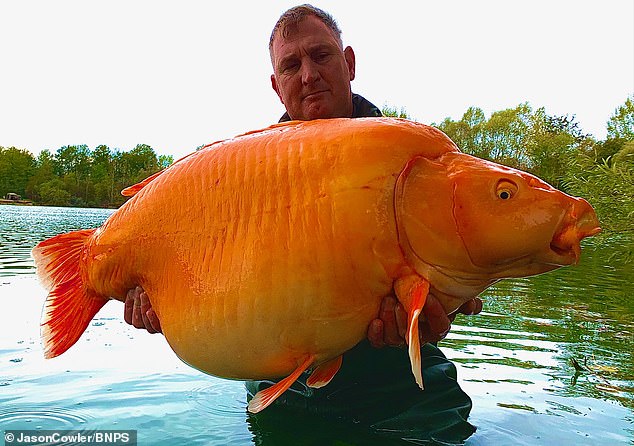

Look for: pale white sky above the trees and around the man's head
[0,0,634,158]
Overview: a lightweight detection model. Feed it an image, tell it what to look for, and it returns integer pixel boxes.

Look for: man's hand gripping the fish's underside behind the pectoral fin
[368,294,482,348]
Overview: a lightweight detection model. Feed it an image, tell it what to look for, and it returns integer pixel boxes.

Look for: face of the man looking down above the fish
[271,16,355,121]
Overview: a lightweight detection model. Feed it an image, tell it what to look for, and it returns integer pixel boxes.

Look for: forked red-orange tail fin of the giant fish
[32,229,108,358]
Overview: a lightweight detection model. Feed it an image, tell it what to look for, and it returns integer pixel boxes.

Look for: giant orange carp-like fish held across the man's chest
[33,118,600,412]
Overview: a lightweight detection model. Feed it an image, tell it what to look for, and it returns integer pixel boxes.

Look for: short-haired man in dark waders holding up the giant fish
[125,5,482,439]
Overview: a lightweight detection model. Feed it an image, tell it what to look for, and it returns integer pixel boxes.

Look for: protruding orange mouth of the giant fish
[550,199,601,265]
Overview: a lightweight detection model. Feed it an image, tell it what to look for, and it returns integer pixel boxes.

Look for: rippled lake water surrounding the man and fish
[0,206,634,446]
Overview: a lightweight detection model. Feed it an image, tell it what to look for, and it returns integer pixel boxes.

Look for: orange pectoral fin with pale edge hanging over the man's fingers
[394,276,429,389]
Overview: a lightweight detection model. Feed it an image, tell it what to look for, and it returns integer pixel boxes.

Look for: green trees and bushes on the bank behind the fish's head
[383,96,634,232]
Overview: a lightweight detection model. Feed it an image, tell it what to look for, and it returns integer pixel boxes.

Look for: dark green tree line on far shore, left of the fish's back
[0,144,173,208]
